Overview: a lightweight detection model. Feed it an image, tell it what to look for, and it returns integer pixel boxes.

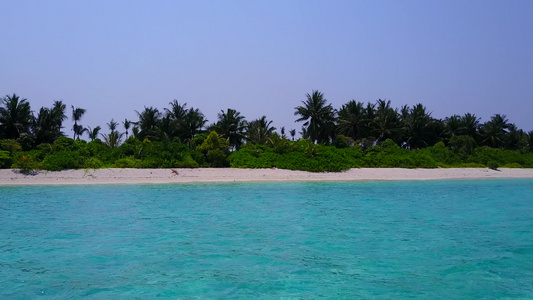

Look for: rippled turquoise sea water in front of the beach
[0,180,533,299]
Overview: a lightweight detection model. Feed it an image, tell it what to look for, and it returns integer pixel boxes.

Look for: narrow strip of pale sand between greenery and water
[0,168,533,185]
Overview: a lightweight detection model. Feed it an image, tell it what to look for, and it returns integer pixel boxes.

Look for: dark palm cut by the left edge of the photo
[0,94,32,139]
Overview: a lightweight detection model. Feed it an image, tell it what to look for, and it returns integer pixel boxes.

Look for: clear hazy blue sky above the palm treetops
[0,0,533,135]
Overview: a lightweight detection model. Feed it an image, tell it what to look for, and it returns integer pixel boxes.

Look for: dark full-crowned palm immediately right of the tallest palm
[337,100,370,140]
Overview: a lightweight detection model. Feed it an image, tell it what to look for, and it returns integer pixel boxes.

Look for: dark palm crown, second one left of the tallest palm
[213,108,247,150]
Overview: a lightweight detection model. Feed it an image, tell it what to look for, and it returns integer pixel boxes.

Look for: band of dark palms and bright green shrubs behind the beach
[0,91,533,174]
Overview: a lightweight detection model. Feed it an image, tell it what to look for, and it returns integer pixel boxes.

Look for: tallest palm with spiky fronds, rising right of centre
[294,91,335,143]
